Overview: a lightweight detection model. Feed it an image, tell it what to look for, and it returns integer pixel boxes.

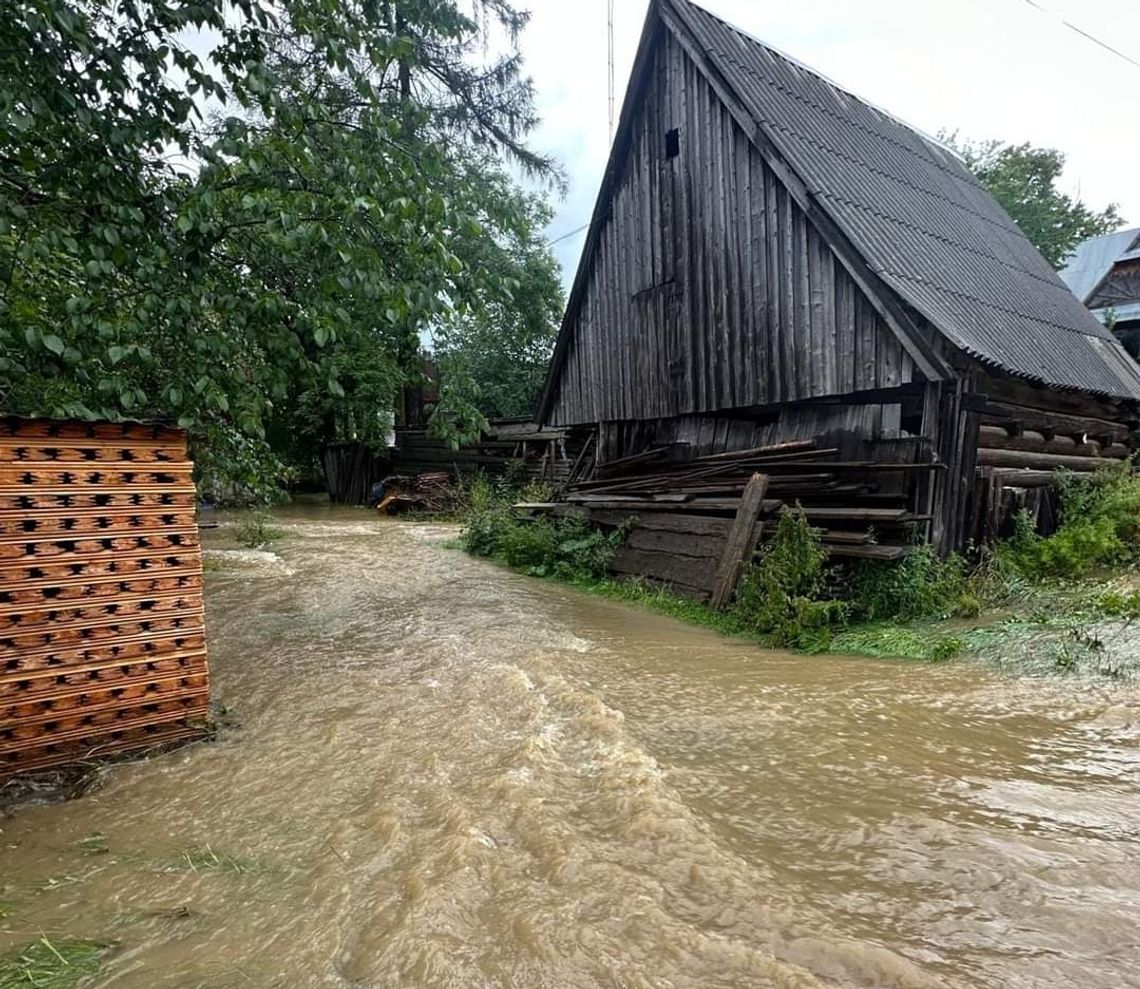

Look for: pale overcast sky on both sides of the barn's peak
[523,0,1140,284]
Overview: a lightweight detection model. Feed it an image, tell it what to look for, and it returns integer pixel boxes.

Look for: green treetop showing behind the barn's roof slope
[939,132,1122,268]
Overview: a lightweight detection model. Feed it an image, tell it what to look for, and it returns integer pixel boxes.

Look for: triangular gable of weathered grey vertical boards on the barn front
[548,33,914,425]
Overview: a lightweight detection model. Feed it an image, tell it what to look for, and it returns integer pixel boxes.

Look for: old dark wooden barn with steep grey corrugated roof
[538,0,1140,578]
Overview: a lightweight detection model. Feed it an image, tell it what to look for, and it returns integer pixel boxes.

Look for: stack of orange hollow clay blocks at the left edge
[0,418,209,778]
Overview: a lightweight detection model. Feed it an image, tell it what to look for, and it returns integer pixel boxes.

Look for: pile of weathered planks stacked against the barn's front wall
[519,440,937,606]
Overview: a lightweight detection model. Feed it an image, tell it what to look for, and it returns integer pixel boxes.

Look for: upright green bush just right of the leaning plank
[733,512,847,652]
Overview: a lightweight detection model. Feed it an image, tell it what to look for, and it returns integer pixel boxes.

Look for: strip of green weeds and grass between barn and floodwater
[459,465,1140,676]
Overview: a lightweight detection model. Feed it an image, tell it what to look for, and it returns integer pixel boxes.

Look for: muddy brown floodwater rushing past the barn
[0,512,1140,989]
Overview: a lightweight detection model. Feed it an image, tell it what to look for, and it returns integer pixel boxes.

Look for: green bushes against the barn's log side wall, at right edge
[996,461,1140,579]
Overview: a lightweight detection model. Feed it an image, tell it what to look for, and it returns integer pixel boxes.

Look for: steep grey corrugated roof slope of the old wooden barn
[668,0,1140,399]
